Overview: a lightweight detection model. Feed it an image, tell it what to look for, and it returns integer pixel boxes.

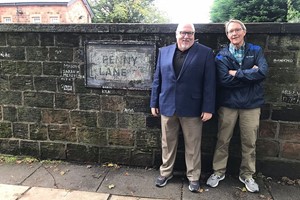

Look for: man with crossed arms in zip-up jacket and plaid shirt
[207,20,268,192]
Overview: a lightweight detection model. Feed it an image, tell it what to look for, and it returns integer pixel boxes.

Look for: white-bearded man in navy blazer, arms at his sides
[150,23,216,192]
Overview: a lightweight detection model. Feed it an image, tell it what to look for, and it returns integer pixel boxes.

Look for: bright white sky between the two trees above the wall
[154,0,214,23]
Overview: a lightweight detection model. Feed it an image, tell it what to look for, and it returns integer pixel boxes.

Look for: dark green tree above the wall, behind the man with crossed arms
[211,0,288,22]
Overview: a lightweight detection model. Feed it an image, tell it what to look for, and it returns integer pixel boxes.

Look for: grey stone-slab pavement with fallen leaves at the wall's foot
[0,158,300,200]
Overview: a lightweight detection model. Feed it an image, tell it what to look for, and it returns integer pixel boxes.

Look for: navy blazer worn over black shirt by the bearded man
[150,42,216,117]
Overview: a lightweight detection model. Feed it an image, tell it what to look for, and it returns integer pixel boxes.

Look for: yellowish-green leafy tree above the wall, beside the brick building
[90,0,168,23]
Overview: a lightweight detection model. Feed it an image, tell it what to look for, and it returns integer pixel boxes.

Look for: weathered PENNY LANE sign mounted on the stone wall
[85,41,156,90]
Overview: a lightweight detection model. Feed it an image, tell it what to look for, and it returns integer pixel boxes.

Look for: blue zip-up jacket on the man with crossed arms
[215,43,268,109]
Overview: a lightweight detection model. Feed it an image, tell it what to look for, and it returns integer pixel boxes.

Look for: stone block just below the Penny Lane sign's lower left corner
[79,94,101,110]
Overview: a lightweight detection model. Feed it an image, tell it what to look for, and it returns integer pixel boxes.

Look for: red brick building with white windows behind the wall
[0,0,93,23]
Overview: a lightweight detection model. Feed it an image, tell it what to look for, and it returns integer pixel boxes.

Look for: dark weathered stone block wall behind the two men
[0,23,300,176]
